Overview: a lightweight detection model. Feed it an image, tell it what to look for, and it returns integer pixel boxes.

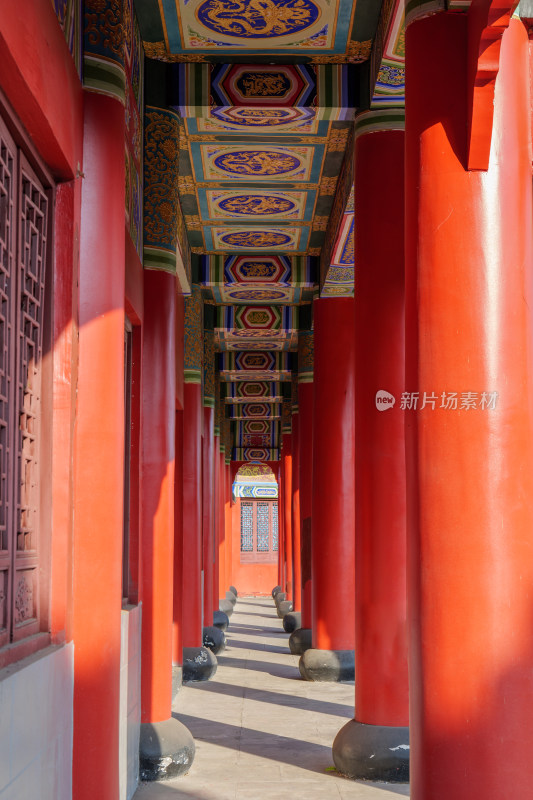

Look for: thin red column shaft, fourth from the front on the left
[202,406,214,626]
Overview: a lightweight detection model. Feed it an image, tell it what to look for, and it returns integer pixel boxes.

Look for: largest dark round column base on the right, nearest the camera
[332,719,409,783]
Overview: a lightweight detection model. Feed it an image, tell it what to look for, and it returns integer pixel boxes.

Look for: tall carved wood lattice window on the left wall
[0,114,49,646]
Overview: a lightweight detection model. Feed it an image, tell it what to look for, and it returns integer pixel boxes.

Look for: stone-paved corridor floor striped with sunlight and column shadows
[134,597,409,800]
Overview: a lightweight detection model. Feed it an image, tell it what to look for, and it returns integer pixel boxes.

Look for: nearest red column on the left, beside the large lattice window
[72,93,125,800]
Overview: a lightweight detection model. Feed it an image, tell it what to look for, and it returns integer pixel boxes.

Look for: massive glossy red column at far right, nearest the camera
[406,14,533,800]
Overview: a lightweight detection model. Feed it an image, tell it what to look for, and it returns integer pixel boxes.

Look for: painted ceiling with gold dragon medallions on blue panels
[135,0,412,462]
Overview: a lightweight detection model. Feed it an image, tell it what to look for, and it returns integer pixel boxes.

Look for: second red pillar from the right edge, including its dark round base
[333,123,409,780]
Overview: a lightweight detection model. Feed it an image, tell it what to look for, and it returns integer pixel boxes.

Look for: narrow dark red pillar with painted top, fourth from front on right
[298,331,314,629]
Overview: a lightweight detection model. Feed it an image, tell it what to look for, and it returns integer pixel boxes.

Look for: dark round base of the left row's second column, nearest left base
[139,717,195,781]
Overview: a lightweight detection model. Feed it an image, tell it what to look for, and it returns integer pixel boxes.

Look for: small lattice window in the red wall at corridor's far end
[241,500,278,563]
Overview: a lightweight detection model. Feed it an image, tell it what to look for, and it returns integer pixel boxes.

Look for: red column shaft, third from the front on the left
[183,383,202,647]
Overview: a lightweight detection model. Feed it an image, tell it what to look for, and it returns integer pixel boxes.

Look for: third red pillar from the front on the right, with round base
[300,298,355,680]
